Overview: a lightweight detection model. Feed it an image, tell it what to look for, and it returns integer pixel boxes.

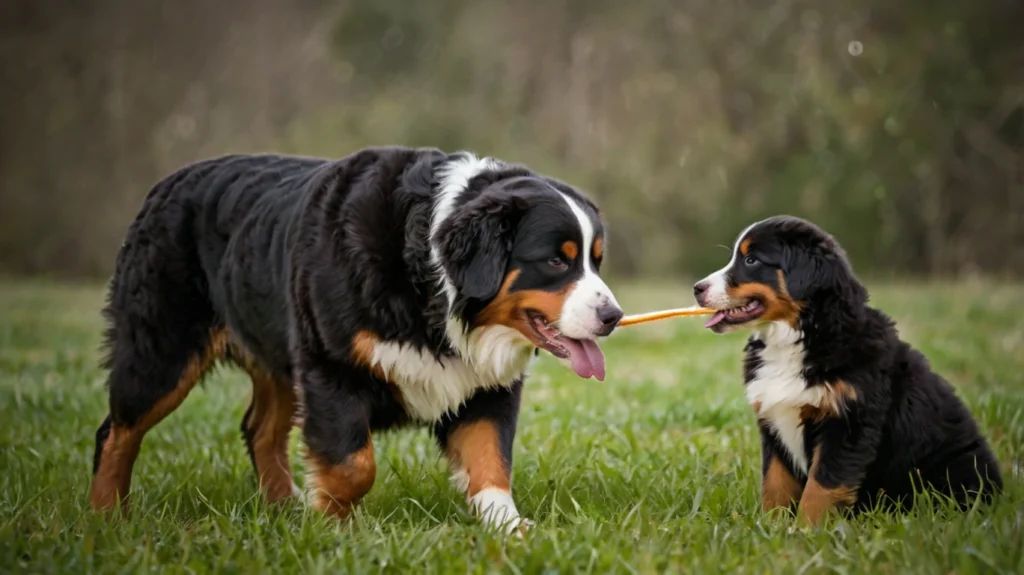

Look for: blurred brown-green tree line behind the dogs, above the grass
[0,0,1024,276]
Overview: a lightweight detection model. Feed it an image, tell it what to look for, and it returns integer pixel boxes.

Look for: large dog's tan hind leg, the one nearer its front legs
[242,361,298,502]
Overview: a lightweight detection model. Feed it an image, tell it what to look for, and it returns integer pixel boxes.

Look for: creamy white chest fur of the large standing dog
[372,326,532,423]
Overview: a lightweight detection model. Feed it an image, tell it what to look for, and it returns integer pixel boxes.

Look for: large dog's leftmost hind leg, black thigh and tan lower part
[89,200,227,510]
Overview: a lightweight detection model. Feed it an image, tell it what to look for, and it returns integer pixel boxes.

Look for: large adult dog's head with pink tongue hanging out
[434,172,623,380]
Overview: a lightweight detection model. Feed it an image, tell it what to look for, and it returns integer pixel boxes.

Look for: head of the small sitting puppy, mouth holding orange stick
[693,216,866,334]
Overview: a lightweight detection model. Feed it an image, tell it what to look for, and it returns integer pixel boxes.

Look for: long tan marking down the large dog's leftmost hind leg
[89,329,227,511]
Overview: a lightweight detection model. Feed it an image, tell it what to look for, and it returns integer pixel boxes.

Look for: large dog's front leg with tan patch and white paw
[434,382,528,533]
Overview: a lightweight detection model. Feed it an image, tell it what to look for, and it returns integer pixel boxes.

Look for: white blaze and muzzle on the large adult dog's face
[558,191,618,340]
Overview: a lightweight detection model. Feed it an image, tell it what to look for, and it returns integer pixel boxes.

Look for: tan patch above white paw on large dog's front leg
[447,421,510,497]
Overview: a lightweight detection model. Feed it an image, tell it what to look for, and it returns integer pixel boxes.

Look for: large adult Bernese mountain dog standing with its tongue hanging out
[90,147,623,530]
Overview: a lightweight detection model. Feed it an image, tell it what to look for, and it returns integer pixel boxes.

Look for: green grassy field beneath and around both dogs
[0,282,1024,573]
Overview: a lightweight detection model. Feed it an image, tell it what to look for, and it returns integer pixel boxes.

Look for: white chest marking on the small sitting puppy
[746,321,827,474]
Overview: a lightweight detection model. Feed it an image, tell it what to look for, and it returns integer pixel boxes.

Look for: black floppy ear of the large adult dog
[434,190,528,300]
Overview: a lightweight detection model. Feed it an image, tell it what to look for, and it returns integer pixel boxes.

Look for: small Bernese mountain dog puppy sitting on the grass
[693,216,1002,525]
